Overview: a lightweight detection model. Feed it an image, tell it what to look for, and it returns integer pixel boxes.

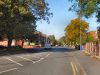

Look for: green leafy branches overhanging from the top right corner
[69,0,100,22]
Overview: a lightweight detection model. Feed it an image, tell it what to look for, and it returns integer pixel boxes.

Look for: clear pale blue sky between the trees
[37,0,98,39]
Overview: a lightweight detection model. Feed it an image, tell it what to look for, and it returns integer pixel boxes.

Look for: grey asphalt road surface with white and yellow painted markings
[0,48,100,75]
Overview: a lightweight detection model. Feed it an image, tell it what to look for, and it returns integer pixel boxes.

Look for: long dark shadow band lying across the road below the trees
[0,48,76,56]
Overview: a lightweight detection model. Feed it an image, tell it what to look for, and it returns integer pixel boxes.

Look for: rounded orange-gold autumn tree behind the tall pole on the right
[65,18,89,45]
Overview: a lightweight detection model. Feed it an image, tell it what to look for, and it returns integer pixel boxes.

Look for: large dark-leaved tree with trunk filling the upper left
[0,0,52,46]
